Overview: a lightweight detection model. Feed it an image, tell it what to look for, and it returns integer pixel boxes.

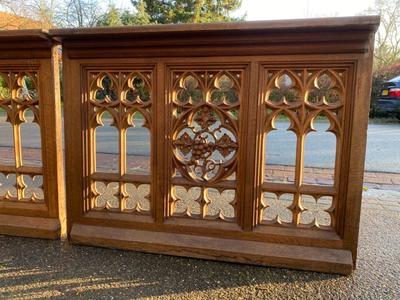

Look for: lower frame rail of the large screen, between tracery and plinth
[76,207,344,249]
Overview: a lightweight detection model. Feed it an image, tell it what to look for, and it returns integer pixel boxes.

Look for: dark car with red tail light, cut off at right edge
[378,76,400,119]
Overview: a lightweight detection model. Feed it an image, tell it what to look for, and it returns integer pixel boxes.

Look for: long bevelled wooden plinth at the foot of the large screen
[71,224,353,275]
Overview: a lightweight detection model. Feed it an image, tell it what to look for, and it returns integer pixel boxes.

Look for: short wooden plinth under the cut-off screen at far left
[0,214,60,239]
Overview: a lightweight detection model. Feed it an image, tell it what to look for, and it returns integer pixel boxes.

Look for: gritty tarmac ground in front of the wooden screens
[0,203,400,299]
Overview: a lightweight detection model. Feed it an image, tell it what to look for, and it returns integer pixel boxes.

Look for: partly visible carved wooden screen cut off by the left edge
[0,30,64,238]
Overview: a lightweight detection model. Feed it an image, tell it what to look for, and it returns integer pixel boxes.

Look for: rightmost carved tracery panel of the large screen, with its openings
[260,67,348,229]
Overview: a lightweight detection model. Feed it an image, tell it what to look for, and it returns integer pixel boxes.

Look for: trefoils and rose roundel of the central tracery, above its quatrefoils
[173,72,240,181]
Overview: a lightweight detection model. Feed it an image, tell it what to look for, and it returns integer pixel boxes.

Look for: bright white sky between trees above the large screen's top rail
[111,0,374,21]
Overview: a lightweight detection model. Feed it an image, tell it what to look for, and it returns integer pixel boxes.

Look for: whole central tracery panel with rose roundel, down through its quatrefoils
[170,68,243,221]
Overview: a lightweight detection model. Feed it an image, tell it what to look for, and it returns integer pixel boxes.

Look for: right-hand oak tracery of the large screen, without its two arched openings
[260,67,347,230]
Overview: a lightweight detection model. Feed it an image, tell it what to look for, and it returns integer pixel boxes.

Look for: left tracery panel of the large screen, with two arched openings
[87,70,153,214]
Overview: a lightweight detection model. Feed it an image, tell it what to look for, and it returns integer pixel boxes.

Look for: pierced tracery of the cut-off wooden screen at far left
[0,69,44,203]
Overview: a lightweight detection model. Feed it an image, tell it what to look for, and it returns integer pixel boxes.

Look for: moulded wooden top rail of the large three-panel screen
[49,16,379,58]
